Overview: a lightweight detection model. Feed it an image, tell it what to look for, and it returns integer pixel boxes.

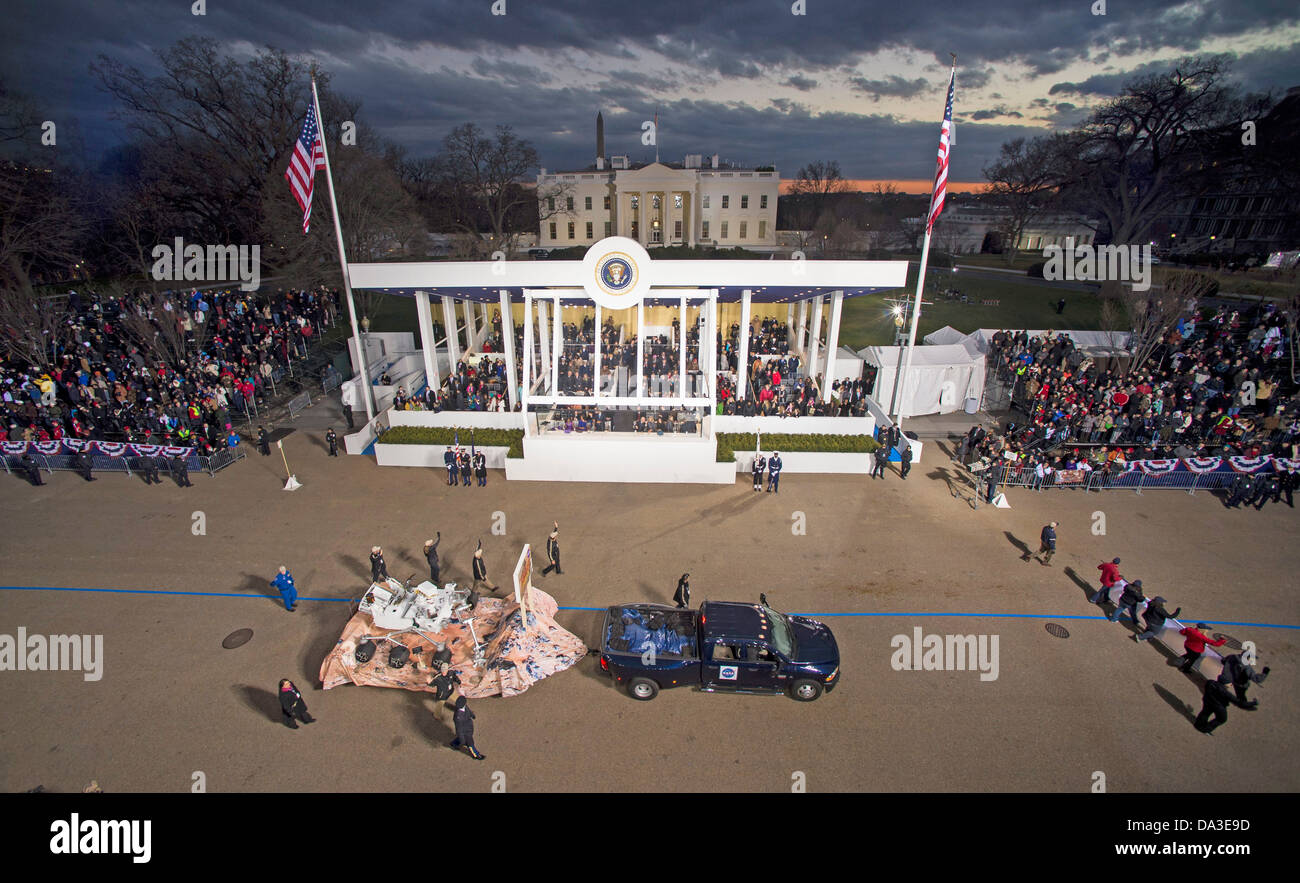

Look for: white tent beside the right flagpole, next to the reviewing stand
[858,342,984,417]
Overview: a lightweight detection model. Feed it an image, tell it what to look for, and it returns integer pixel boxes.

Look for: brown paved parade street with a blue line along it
[0,433,1300,792]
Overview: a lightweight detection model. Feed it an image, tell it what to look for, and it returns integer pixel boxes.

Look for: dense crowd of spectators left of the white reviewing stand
[0,289,338,454]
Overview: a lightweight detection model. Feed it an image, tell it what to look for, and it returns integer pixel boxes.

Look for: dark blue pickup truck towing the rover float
[601,601,840,702]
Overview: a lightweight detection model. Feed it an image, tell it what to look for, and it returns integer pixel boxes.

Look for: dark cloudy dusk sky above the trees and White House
[0,0,1300,181]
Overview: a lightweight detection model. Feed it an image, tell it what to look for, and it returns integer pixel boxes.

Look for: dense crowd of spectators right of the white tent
[966,304,1300,475]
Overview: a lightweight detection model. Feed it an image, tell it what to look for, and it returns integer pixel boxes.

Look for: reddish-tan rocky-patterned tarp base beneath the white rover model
[321,588,586,698]
